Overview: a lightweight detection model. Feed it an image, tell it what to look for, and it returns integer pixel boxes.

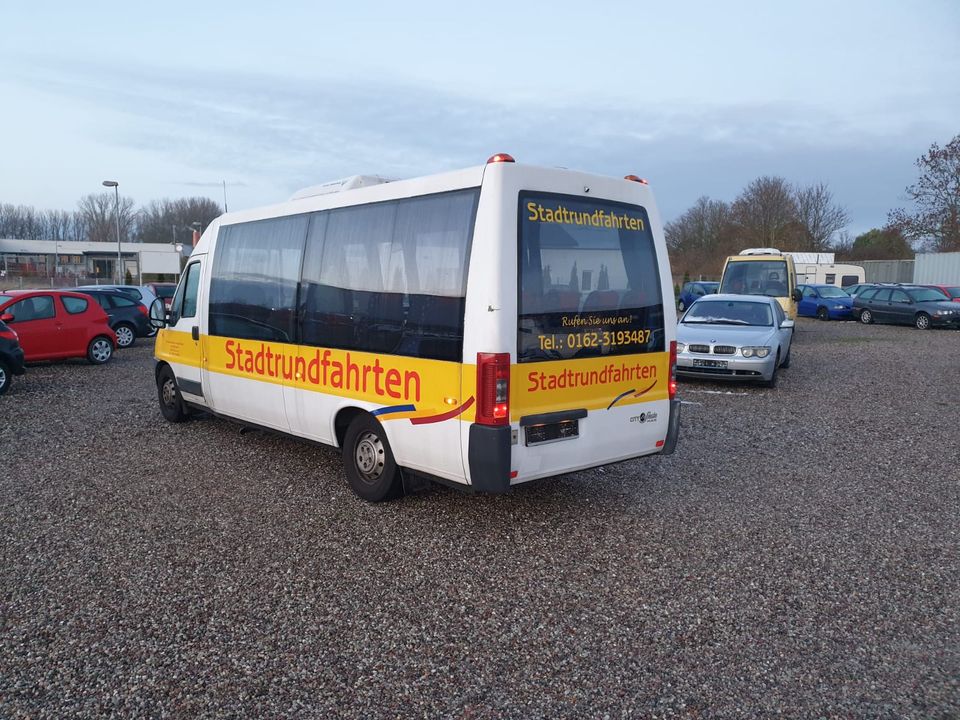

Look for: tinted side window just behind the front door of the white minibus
[210,214,310,342]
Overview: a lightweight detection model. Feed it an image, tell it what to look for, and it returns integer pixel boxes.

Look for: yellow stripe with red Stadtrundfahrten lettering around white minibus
[156,328,669,422]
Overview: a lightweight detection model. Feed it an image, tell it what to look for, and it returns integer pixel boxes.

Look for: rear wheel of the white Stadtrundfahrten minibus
[343,413,403,502]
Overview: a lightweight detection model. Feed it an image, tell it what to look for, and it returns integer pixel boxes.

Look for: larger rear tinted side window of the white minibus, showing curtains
[301,190,478,360]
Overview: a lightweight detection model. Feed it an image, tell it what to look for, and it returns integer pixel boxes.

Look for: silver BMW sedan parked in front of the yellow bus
[677,295,794,387]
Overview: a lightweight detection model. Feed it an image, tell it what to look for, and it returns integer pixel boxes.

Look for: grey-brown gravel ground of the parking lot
[0,320,960,718]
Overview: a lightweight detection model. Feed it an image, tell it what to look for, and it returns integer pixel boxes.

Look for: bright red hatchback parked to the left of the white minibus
[0,290,117,365]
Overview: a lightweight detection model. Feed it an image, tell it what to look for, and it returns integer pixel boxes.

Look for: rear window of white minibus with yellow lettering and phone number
[517,193,665,362]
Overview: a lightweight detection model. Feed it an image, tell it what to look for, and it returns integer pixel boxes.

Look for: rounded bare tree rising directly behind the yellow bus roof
[732,175,797,247]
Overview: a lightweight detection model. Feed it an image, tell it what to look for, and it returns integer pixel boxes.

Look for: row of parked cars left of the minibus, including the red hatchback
[0,285,163,395]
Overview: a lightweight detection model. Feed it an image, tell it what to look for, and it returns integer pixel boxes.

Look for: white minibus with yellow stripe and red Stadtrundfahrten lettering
[155,154,680,501]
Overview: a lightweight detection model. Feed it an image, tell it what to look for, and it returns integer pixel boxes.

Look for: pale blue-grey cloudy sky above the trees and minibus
[0,0,960,233]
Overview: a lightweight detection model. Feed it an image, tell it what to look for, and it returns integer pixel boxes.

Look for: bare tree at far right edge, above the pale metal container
[888,135,960,252]
